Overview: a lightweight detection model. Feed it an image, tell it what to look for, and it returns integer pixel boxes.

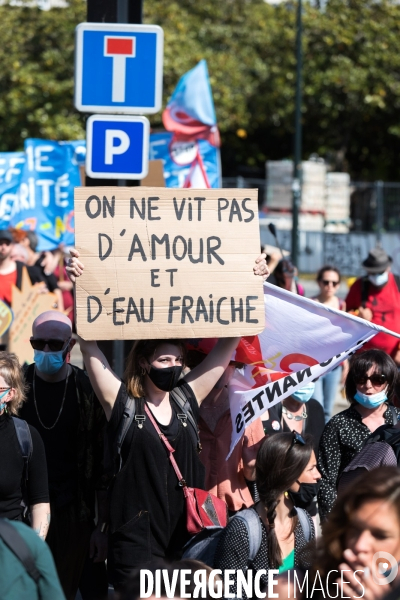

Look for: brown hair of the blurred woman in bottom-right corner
[313,467,400,577]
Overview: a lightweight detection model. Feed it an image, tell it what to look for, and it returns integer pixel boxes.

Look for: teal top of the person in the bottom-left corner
[0,521,65,600]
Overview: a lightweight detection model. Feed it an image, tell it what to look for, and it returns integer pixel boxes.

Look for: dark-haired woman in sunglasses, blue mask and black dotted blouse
[318,350,400,519]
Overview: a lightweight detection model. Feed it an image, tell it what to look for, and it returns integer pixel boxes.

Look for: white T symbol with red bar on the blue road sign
[104,35,136,102]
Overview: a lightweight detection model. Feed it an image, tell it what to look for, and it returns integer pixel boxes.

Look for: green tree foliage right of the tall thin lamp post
[304,0,400,180]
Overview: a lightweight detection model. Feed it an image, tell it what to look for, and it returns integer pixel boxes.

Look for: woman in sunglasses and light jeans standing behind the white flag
[312,265,349,423]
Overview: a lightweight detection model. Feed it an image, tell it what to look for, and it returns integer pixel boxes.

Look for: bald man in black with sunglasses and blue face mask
[20,311,108,600]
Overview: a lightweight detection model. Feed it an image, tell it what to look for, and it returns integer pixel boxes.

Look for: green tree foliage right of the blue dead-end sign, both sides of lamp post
[145,0,400,179]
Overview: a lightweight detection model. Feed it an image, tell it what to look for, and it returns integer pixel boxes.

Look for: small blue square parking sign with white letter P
[86,115,150,179]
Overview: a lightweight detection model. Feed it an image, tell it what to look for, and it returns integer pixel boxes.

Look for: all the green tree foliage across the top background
[0,0,400,180]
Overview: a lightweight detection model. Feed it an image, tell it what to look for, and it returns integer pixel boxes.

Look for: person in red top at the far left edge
[0,229,44,306]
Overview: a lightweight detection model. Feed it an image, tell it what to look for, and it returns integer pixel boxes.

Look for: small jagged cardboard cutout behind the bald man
[8,268,57,364]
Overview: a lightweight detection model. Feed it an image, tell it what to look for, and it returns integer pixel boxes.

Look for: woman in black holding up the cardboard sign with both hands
[68,251,268,590]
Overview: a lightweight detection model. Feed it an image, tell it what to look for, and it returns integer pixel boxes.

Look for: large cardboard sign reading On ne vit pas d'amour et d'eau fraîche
[75,187,265,340]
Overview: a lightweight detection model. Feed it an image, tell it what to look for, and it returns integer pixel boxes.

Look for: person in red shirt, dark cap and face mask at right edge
[346,246,400,366]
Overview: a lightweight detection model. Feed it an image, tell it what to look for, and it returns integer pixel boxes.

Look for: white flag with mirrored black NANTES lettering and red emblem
[228,283,382,457]
